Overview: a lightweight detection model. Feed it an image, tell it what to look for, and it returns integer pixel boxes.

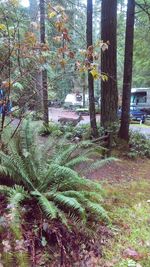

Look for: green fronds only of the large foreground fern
[0,121,108,229]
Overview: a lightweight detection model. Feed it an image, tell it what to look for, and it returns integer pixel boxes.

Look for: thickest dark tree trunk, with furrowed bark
[101,0,118,128]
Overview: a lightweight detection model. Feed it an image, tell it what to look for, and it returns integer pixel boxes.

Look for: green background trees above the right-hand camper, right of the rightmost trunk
[132,0,150,87]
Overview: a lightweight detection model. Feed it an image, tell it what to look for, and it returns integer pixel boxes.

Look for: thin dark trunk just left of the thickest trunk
[86,0,98,137]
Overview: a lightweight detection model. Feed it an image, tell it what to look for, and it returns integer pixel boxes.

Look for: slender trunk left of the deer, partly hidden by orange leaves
[40,0,49,124]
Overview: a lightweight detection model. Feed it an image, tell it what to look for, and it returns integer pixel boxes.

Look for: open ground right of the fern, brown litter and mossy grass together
[84,159,150,267]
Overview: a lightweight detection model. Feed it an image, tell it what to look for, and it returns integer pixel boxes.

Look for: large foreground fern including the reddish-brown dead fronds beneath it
[0,121,108,266]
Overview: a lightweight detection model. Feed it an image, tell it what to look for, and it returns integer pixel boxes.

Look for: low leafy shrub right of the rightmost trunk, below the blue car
[128,132,150,158]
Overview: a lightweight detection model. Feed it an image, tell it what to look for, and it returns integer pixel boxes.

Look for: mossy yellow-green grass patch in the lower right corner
[104,180,150,267]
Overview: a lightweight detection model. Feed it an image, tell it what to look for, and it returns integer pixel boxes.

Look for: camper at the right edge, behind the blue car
[130,88,150,113]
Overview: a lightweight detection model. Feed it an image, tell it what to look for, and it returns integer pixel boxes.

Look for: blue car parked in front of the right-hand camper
[118,106,147,123]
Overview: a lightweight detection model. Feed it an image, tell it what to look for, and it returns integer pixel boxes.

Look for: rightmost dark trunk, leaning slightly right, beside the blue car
[119,0,135,141]
